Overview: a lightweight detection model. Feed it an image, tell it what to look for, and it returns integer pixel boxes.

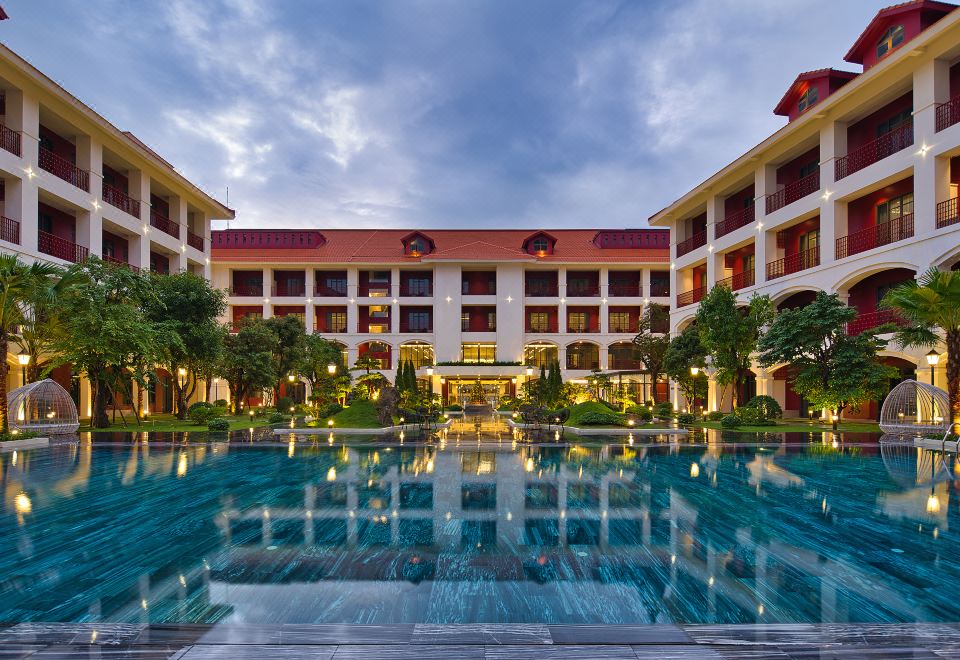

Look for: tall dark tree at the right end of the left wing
[144,272,227,419]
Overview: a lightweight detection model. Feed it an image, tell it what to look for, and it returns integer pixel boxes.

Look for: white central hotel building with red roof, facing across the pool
[212,229,670,403]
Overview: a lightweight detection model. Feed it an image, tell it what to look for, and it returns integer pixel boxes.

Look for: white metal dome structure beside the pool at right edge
[880,380,950,435]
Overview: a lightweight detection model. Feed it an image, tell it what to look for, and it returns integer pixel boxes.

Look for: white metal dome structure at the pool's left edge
[7,378,80,435]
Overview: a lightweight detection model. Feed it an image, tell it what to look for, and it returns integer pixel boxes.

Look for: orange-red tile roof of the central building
[210,229,670,263]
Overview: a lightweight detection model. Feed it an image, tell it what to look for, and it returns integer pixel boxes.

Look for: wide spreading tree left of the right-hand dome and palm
[758,292,896,429]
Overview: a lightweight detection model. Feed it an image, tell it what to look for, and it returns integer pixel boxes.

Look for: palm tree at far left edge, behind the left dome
[0,254,61,434]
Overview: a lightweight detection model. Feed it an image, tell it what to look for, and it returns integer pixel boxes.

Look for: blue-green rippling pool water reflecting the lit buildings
[0,434,960,624]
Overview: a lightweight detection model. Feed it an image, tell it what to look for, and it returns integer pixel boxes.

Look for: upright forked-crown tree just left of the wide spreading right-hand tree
[696,286,775,408]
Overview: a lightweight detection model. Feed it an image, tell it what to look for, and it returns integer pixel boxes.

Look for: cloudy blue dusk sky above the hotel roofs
[0,0,892,228]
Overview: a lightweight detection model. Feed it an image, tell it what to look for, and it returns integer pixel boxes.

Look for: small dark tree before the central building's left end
[217,319,277,414]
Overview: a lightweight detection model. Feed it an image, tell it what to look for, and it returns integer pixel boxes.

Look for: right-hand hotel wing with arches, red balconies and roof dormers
[650,0,960,417]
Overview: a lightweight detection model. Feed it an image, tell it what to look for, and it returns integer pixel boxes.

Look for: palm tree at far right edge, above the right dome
[881,268,960,435]
